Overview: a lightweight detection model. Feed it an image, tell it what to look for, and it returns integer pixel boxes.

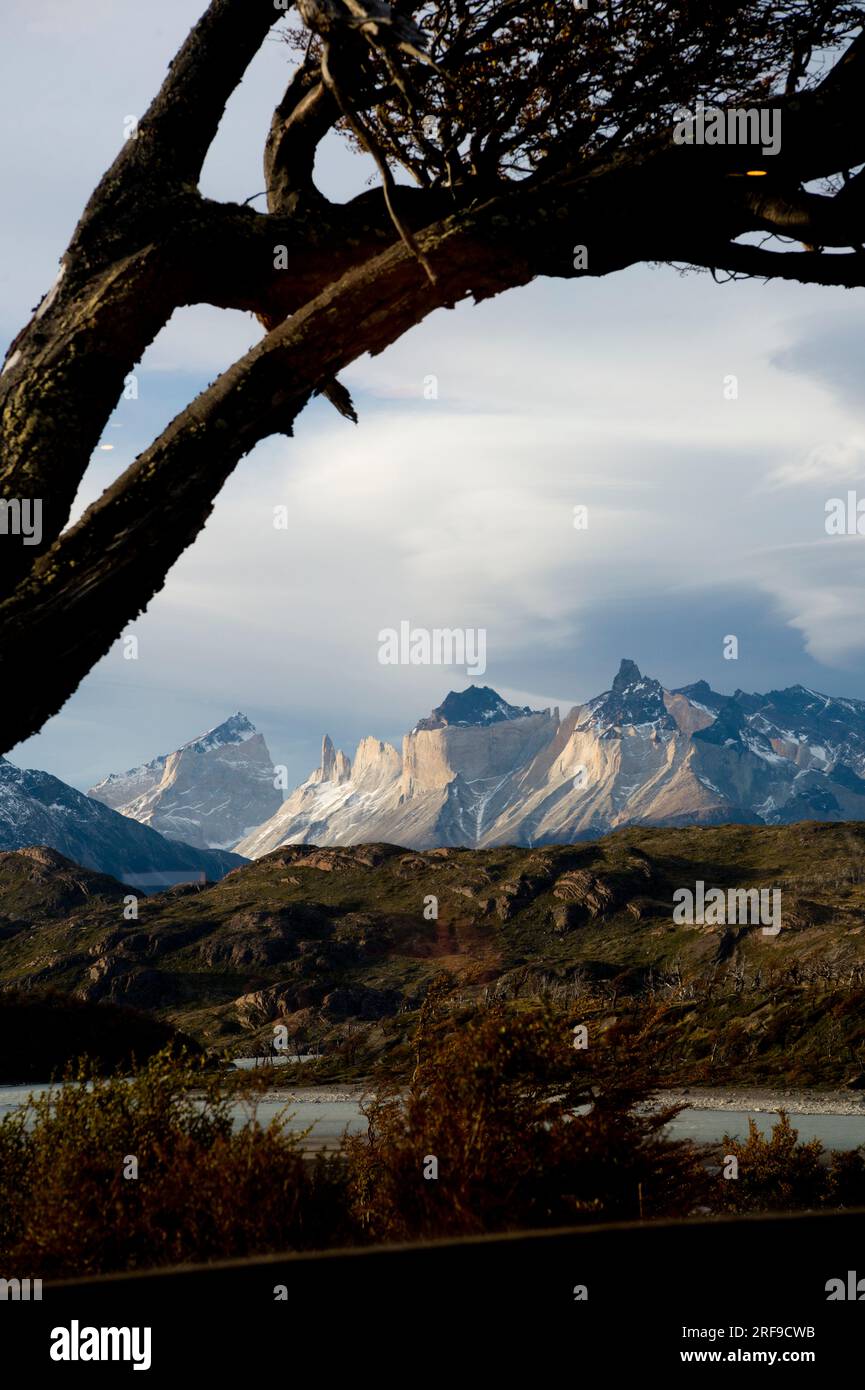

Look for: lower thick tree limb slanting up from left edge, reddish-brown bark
[0,180,645,748]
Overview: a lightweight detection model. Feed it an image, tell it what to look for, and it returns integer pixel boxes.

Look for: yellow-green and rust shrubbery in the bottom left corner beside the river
[0,1052,349,1277]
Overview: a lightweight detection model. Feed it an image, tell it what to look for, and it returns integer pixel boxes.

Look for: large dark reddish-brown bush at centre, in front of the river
[343,986,706,1241]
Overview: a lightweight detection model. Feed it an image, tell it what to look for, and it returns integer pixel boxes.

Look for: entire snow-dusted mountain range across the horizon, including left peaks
[10,660,865,887]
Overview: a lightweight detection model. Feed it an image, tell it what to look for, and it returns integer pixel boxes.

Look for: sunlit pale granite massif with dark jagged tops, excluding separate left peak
[235,659,865,859]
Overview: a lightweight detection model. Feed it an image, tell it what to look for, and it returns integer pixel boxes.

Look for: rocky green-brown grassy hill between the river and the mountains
[0,821,865,1086]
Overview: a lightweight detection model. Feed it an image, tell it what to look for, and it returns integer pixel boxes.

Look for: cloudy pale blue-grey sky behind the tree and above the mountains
[0,0,865,788]
